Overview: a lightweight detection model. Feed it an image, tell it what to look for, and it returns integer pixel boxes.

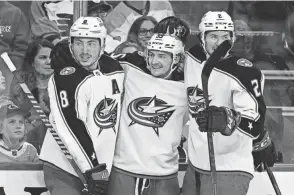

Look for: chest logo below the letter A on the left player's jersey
[94,97,117,135]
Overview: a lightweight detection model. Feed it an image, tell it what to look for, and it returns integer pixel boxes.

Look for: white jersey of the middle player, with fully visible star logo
[113,54,188,177]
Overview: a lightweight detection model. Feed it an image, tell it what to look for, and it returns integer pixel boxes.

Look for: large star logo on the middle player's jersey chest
[128,96,175,136]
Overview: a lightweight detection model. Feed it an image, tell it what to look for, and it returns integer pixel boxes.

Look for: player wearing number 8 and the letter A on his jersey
[40,17,124,195]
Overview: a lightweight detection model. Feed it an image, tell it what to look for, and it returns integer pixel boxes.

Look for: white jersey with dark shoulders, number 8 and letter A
[40,55,124,176]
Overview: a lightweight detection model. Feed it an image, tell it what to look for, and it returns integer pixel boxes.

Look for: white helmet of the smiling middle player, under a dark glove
[146,33,184,78]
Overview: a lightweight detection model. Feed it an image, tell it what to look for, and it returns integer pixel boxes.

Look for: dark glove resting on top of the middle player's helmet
[154,16,191,44]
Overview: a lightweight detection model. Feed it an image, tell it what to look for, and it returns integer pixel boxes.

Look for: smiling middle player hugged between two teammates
[109,34,188,195]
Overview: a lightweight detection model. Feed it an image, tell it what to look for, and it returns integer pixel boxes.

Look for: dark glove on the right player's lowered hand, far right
[252,131,277,172]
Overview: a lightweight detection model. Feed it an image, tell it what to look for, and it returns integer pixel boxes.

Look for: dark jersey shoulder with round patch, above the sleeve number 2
[215,56,262,87]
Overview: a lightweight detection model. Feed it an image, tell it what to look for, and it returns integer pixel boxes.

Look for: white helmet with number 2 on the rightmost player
[199,11,236,50]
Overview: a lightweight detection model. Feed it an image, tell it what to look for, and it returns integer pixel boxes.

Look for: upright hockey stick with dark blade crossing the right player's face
[201,40,232,195]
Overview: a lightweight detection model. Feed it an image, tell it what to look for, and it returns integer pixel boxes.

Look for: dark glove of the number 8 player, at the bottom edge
[86,163,109,195]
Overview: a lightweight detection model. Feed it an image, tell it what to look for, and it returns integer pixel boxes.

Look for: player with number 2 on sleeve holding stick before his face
[183,11,273,195]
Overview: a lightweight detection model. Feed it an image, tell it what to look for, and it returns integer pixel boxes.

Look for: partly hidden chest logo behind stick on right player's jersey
[187,85,211,115]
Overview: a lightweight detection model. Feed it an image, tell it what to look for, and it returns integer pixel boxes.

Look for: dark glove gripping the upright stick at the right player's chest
[194,106,241,136]
